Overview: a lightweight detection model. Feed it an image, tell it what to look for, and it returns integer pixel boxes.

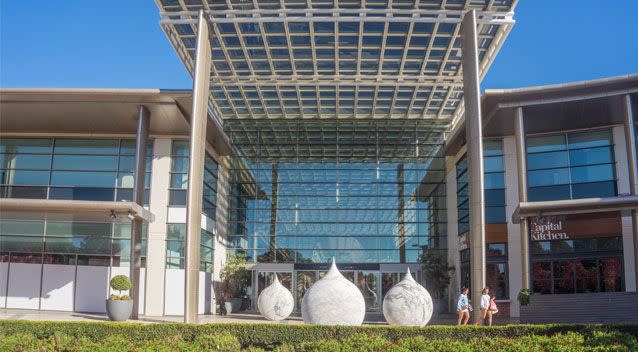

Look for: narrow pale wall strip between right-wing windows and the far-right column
[612,126,636,291]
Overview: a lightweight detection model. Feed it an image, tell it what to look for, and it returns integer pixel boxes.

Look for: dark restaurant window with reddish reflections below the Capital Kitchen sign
[530,237,623,294]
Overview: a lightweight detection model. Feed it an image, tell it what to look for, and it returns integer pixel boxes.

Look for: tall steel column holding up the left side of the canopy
[184,10,211,323]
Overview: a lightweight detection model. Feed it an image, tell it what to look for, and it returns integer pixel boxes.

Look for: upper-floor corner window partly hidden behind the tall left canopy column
[169,140,218,220]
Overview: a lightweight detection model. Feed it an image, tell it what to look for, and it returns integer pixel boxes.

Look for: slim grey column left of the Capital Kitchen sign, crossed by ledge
[514,107,530,289]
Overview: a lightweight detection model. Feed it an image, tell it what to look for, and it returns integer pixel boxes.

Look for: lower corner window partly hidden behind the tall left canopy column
[166,224,215,272]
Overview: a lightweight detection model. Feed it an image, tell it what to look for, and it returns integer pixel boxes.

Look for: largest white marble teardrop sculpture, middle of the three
[301,258,366,325]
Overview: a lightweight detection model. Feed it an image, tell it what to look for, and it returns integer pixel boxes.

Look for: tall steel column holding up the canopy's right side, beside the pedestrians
[461,10,485,322]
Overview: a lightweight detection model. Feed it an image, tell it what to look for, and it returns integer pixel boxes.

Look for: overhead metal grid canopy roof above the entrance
[156,0,517,120]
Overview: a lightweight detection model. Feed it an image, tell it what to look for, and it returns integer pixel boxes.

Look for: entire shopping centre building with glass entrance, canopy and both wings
[0,0,638,321]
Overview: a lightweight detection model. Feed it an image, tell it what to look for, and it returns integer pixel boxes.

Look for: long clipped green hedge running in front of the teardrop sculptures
[0,320,638,348]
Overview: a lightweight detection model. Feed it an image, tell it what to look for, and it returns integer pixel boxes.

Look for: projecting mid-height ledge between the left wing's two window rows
[0,198,155,222]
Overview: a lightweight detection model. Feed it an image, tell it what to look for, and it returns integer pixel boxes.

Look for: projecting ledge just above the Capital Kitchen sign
[512,196,638,224]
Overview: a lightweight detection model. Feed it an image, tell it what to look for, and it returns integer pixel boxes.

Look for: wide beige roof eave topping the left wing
[0,88,231,155]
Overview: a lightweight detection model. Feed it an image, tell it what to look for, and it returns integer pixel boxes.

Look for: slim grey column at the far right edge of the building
[622,94,638,284]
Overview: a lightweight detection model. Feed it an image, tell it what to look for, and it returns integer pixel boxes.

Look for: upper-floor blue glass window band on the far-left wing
[0,138,153,204]
